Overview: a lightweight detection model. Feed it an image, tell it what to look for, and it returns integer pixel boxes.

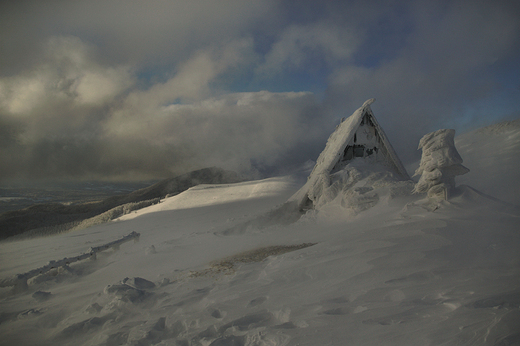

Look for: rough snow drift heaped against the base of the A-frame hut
[216,158,414,236]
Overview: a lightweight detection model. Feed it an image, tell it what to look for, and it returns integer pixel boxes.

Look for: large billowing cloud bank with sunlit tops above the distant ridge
[0,33,324,179]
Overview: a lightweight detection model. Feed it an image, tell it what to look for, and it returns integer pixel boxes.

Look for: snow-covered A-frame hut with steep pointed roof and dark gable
[290,99,410,209]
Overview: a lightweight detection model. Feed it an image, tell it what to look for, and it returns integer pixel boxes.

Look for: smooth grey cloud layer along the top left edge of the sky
[0,0,276,73]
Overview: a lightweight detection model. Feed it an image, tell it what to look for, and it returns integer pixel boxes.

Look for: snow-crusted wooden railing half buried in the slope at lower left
[0,231,140,291]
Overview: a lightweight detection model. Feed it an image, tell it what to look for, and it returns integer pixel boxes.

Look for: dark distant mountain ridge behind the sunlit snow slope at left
[0,167,242,240]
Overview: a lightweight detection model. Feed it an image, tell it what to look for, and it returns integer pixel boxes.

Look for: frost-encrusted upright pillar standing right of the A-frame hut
[413,129,469,199]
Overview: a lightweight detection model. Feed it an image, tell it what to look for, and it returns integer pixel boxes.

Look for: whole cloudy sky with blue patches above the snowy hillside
[0,0,520,183]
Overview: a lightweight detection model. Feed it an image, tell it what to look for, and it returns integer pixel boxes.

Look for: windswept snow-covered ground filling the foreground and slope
[0,122,520,346]
